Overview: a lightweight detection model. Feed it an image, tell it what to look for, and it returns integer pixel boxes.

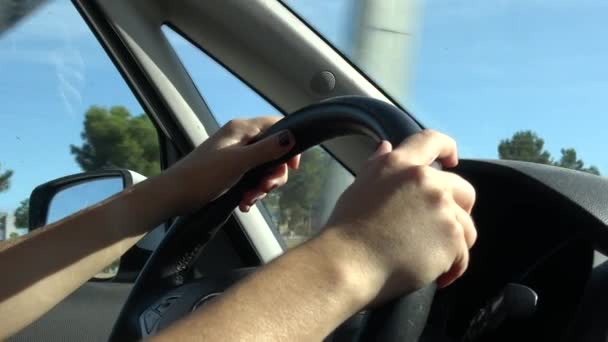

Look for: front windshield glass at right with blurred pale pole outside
[284,0,608,173]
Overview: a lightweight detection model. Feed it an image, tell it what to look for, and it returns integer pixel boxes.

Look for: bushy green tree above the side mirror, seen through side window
[70,106,160,177]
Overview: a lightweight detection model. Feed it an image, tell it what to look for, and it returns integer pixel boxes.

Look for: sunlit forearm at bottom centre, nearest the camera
[156,230,379,341]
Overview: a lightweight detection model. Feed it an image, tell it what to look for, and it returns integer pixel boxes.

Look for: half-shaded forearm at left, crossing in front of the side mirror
[0,171,184,339]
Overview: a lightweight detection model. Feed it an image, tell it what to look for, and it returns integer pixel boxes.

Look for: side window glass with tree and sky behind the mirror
[0,0,160,252]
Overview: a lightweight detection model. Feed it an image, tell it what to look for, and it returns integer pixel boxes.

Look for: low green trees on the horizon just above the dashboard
[498,130,600,175]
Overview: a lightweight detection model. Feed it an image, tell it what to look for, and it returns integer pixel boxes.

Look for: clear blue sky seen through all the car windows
[0,0,608,211]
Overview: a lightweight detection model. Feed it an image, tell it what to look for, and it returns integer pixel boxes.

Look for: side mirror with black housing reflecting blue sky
[29,169,145,231]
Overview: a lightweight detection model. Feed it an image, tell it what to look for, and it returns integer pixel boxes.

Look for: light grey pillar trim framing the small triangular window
[73,0,418,262]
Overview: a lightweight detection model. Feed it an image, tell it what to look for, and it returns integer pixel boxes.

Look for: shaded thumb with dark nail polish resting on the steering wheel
[244,130,295,167]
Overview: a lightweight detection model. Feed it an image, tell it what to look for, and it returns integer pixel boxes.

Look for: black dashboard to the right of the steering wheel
[133,161,608,342]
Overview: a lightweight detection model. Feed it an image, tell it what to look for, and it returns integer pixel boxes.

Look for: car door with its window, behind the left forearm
[0,0,164,341]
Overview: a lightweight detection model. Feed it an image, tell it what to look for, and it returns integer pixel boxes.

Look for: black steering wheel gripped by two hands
[110,96,438,342]
